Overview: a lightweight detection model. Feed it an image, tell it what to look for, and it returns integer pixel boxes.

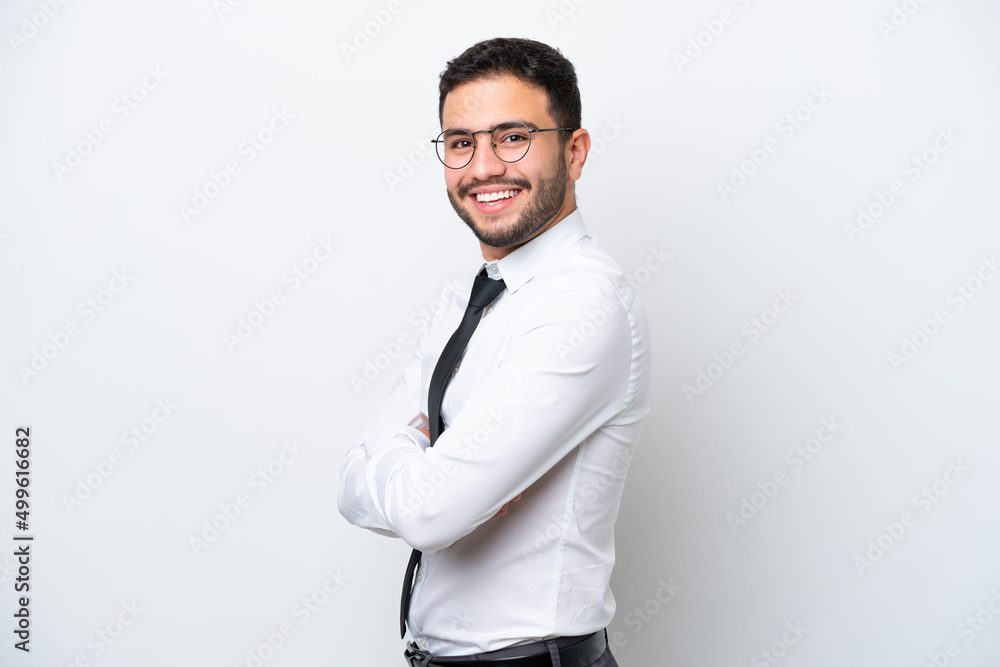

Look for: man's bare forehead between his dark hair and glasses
[441,76,553,130]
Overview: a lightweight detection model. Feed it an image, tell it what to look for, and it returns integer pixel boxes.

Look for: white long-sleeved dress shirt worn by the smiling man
[338,210,649,656]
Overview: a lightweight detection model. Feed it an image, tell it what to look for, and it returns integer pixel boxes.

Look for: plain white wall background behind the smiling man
[0,0,1000,667]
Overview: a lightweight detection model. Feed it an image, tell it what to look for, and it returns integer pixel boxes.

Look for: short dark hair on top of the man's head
[438,37,581,129]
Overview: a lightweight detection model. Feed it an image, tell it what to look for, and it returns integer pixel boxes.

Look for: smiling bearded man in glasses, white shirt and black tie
[339,39,649,667]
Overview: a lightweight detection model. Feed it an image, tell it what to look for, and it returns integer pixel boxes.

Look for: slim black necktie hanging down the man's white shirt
[399,269,507,639]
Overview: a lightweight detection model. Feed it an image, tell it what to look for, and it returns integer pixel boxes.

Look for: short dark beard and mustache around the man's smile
[448,160,569,248]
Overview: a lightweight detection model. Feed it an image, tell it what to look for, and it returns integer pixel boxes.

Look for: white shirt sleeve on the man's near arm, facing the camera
[357,281,633,552]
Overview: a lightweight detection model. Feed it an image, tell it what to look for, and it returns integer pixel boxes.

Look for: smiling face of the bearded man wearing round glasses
[441,76,572,253]
